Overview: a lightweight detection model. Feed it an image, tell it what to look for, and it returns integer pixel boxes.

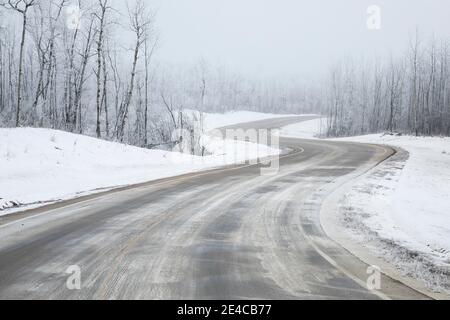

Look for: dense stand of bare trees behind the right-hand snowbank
[323,33,450,136]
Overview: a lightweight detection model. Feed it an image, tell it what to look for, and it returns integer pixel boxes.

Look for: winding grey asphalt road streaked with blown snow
[0,118,426,299]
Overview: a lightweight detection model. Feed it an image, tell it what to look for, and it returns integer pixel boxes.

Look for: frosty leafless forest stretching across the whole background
[0,0,450,147]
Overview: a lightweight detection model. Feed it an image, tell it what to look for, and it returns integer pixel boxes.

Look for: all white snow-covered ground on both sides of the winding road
[0,112,450,293]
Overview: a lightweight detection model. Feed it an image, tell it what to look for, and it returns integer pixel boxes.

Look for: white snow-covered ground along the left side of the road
[0,112,280,215]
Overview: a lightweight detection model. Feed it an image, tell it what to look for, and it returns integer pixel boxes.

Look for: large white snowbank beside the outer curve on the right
[339,135,450,276]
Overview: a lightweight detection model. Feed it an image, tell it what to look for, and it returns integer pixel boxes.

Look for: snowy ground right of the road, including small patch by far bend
[281,120,450,294]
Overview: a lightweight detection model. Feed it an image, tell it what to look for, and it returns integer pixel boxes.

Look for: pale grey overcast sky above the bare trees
[146,0,450,77]
